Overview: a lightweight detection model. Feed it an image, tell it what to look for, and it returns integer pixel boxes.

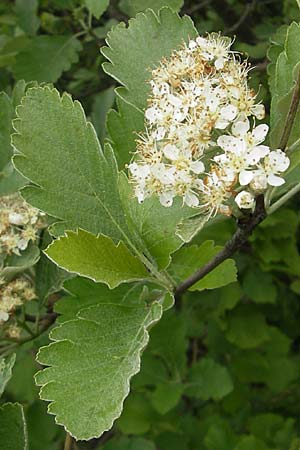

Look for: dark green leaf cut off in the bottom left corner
[0,403,28,450]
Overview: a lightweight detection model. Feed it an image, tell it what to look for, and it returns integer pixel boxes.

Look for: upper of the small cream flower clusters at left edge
[0,194,45,255]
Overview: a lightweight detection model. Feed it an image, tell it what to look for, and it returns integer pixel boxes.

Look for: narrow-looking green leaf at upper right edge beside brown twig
[270,22,300,148]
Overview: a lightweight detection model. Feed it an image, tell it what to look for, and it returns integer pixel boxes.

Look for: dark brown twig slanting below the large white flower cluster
[175,195,266,301]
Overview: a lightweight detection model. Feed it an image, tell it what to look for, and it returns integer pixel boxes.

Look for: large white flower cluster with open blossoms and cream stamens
[128,33,289,215]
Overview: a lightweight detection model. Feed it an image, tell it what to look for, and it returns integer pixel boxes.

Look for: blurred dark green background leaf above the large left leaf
[13,36,82,83]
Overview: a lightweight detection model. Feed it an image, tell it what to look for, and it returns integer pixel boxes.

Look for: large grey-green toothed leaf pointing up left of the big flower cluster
[13,87,130,241]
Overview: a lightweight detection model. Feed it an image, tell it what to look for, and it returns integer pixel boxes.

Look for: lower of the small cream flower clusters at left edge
[0,278,36,324]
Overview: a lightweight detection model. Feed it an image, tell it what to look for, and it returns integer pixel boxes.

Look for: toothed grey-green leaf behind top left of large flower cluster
[102,8,197,109]
